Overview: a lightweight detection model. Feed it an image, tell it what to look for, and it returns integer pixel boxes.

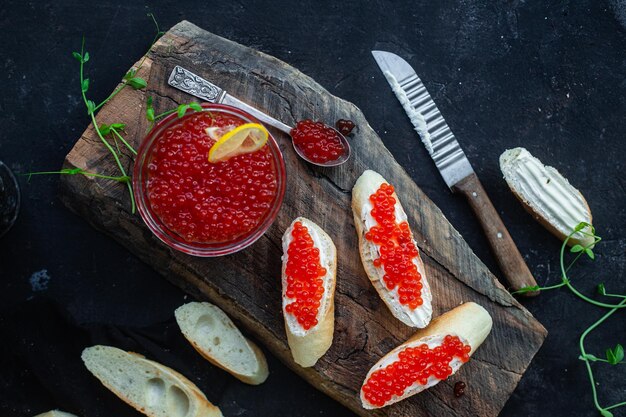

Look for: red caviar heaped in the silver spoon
[291,119,346,164]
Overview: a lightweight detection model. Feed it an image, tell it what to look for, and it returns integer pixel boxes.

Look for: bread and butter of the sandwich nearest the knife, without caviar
[352,170,432,328]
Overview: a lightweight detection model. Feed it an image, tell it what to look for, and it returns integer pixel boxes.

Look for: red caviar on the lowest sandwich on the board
[361,335,472,407]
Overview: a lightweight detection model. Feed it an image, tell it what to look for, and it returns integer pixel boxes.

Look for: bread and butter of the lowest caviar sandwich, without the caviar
[361,302,493,409]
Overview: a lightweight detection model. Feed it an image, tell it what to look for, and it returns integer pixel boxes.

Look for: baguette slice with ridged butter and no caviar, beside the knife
[500,148,594,246]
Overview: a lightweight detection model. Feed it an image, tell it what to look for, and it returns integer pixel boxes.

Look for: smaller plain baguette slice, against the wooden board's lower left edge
[174,302,269,385]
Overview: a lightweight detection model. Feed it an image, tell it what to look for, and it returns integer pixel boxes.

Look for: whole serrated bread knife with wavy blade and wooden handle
[372,51,538,296]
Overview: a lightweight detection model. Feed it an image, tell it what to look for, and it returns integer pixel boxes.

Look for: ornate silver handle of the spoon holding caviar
[167,65,291,135]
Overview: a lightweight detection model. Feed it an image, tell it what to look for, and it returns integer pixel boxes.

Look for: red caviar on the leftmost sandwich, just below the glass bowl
[285,222,327,330]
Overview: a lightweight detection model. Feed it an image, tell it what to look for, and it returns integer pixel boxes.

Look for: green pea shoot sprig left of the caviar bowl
[25,13,164,214]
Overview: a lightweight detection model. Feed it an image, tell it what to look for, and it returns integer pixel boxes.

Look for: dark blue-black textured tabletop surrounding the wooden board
[0,0,626,417]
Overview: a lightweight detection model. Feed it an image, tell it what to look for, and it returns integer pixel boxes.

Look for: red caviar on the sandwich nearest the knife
[365,184,424,309]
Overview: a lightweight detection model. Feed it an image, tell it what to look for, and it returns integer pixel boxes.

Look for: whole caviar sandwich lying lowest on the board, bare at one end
[361,302,492,409]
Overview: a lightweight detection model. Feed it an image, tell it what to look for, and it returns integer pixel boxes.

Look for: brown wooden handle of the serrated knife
[452,173,539,296]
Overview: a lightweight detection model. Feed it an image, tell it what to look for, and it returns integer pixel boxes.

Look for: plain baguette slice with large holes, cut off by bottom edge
[82,345,222,417]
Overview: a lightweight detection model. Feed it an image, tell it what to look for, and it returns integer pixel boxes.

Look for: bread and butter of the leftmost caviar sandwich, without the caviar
[281,217,337,368]
